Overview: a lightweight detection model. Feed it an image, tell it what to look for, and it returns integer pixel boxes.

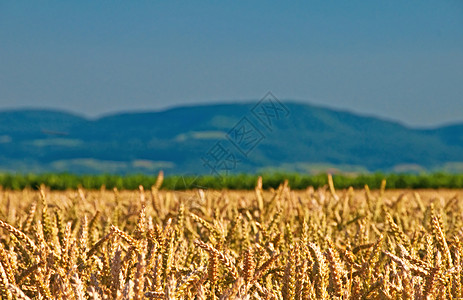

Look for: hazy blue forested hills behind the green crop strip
[0,102,463,174]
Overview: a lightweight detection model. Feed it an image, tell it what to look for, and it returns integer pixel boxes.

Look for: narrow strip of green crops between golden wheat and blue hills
[0,173,463,190]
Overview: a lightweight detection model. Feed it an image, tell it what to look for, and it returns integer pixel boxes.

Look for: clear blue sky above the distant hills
[0,0,463,126]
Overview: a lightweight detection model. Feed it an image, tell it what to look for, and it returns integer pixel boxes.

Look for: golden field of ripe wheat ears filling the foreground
[0,178,463,299]
